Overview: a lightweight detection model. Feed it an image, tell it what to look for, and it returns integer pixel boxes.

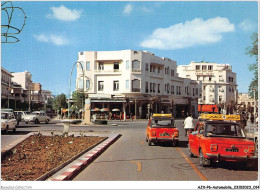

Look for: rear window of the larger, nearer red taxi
[205,124,245,138]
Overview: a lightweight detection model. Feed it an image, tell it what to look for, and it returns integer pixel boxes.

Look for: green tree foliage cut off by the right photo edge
[246,32,258,99]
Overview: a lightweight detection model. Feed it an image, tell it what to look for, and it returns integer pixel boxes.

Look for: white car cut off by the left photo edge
[1,112,16,133]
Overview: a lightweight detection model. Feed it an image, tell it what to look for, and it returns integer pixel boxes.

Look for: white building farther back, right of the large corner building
[177,62,237,112]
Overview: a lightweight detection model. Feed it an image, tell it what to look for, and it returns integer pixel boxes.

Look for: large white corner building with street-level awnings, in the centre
[76,50,201,118]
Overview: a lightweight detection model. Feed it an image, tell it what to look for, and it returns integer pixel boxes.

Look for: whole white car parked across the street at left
[23,111,50,124]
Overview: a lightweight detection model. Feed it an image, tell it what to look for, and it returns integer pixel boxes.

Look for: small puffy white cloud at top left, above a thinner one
[47,5,82,21]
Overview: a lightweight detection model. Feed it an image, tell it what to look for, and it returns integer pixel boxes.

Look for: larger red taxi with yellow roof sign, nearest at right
[188,114,257,167]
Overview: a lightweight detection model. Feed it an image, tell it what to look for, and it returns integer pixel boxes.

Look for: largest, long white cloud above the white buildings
[140,17,235,50]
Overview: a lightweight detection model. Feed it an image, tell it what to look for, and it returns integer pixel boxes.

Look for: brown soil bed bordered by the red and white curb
[1,134,106,181]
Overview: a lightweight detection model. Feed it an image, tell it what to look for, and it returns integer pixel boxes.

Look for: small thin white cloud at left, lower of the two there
[33,34,69,46]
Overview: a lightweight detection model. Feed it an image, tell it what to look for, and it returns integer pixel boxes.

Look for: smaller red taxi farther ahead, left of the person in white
[146,114,179,146]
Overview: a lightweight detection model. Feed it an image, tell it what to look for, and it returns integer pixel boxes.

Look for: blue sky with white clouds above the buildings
[1,1,258,95]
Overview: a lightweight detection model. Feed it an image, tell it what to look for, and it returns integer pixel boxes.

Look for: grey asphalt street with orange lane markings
[1,120,258,181]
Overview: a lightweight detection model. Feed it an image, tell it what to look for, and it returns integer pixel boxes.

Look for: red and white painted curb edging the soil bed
[47,134,121,181]
